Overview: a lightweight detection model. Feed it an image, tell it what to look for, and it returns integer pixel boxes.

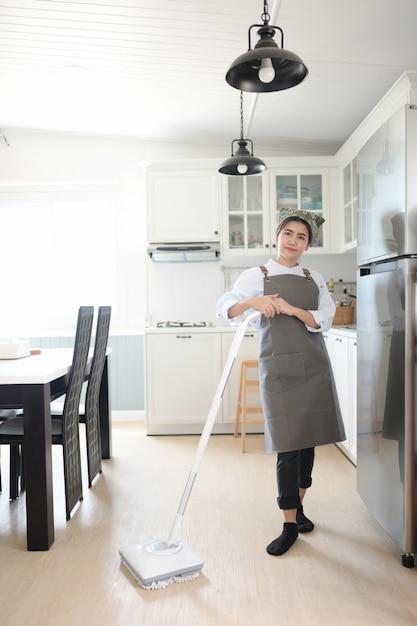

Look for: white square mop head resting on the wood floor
[119,541,203,591]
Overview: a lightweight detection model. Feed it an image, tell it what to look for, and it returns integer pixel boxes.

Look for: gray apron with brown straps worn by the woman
[259,266,346,453]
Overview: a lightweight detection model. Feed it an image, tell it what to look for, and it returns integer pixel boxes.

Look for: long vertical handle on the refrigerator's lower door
[404,270,417,553]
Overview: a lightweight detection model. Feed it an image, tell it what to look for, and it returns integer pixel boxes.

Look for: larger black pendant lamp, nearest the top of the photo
[226,2,308,92]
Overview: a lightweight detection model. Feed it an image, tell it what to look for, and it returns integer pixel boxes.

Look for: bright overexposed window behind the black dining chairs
[0,185,118,339]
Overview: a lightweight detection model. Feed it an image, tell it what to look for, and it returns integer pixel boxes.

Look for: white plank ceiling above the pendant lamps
[0,0,417,155]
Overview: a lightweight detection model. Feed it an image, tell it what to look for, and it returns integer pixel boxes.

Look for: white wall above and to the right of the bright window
[0,130,240,334]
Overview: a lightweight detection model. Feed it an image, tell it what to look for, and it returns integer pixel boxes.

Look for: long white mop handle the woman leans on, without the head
[167,311,259,545]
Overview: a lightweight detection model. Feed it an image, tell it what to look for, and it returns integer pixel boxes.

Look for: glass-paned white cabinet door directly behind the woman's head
[270,168,330,253]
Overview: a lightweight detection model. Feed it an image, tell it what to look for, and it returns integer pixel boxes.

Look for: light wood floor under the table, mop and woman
[0,423,417,626]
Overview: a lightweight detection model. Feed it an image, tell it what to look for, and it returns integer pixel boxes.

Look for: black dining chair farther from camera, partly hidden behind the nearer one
[51,306,111,487]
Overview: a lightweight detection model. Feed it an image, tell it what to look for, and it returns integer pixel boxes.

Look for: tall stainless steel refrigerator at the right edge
[356,105,417,567]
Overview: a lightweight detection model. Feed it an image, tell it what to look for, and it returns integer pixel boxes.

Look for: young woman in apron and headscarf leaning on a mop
[216,208,345,556]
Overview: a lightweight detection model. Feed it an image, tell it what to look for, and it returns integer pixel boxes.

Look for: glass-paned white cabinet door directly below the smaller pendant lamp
[223,175,269,254]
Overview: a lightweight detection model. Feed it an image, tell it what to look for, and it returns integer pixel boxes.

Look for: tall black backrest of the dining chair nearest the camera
[62,306,94,519]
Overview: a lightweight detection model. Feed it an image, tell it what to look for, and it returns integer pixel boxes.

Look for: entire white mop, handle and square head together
[119,311,259,590]
